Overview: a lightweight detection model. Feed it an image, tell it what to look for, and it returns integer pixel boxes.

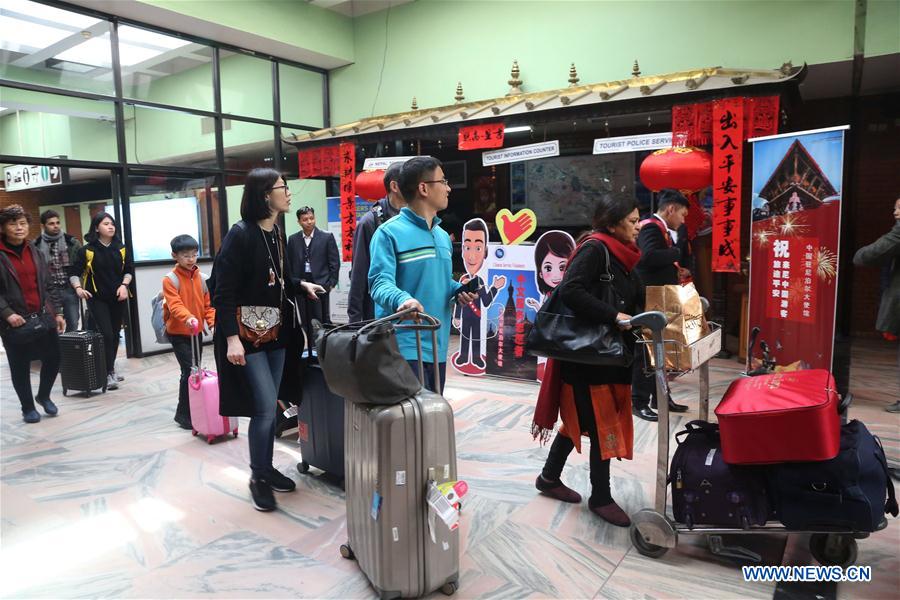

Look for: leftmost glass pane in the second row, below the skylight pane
[0,87,118,162]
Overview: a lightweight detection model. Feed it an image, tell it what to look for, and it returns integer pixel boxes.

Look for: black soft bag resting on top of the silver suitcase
[313,311,432,404]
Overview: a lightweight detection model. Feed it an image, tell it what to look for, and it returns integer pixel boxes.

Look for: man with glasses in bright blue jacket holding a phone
[369,156,476,393]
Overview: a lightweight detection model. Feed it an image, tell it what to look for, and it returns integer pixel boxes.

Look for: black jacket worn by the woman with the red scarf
[560,241,644,385]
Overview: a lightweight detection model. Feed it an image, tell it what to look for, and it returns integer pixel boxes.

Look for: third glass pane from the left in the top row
[219,50,273,119]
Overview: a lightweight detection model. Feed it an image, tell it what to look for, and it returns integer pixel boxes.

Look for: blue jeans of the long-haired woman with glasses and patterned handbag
[244,348,284,479]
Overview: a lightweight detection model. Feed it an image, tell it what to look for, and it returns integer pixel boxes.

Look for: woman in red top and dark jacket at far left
[0,204,66,423]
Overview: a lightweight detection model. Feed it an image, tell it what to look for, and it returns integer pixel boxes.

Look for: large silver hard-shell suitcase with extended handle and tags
[341,313,459,598]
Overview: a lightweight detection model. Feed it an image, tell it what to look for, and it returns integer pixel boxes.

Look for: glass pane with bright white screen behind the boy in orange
[129,173,221,261]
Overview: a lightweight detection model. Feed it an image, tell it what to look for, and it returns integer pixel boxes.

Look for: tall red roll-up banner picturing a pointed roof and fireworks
[748,127,846,369]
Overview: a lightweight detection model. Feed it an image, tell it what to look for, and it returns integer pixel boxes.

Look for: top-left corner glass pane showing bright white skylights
[0,0,115,95]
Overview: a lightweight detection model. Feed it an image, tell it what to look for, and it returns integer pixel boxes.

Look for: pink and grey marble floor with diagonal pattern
[0,341,900,599]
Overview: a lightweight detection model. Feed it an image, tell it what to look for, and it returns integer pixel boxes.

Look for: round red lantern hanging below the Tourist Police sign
[640,146,712,192]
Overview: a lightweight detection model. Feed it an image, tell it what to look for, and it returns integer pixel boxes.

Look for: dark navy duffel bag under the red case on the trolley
[769,420,898,532]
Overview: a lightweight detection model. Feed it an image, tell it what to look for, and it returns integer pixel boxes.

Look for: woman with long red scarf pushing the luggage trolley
[532,196,644,527]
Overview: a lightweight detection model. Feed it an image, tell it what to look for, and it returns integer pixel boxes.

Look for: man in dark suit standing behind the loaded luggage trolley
[631,189,690,421]
